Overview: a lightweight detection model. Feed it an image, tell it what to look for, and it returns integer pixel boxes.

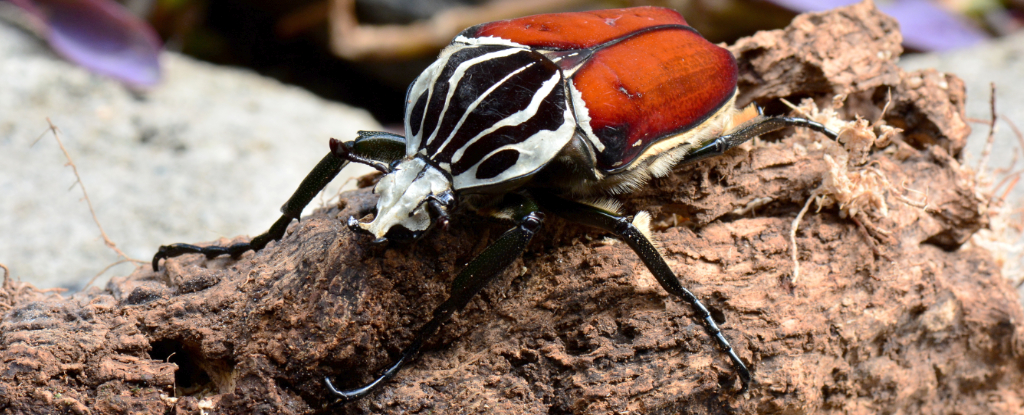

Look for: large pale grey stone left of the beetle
[0,22,380,289]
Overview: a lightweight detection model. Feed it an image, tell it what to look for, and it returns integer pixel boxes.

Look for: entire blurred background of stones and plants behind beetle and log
[0,0,1024,290]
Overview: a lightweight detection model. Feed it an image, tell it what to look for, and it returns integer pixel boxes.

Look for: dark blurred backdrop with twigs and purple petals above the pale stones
[8,0,1024,126]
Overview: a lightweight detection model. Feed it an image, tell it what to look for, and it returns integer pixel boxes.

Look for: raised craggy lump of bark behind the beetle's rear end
[729,1,971,156]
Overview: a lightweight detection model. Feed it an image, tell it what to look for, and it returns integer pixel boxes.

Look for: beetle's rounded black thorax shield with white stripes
[406,43,575,190]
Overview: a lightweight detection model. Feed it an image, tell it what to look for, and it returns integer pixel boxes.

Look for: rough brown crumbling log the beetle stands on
[0,4,1024,414]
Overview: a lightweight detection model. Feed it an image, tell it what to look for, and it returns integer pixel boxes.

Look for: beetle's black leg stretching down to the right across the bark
[531,192,751,390]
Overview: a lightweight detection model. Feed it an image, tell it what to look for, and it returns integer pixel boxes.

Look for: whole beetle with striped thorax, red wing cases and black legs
[153,7,837,402]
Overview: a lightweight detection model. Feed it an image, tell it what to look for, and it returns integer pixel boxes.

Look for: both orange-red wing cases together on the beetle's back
[465,7,737,171]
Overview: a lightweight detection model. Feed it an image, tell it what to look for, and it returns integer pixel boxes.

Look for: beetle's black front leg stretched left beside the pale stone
[153,131,406,271]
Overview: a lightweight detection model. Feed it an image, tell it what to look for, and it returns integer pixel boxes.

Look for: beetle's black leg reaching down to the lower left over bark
[324,194,544,404]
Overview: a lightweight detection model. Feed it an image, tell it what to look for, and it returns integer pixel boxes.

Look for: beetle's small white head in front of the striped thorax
[356,157,454,241]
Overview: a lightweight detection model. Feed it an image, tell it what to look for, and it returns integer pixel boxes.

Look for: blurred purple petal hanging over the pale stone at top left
[14,0,162,86]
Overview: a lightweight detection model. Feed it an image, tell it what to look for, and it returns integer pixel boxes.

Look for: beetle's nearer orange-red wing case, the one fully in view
[571,29,736,172]
